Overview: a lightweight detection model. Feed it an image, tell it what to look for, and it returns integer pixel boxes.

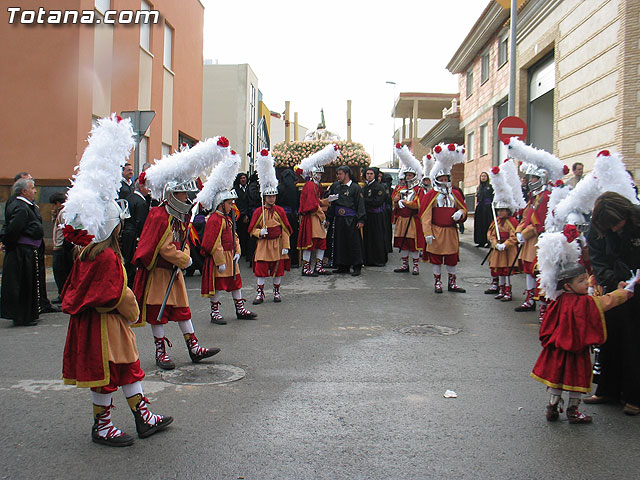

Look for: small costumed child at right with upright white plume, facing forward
[484,159,524,302]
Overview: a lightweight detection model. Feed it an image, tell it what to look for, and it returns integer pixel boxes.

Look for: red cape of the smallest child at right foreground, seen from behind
[531,293,607,392]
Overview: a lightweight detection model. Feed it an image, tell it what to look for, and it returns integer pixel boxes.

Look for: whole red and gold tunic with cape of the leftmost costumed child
[62,248,144,387]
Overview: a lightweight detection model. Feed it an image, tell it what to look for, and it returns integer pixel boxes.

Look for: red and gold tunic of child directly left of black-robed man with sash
[298,181,329,250]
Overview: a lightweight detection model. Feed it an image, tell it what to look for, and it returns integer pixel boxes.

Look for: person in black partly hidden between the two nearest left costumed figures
[120,181,151,288]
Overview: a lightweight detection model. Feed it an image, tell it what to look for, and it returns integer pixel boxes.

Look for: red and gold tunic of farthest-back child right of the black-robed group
[391,185,424,252]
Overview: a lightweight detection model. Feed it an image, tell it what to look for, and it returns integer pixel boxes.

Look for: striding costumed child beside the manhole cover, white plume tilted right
[133,137,229,370]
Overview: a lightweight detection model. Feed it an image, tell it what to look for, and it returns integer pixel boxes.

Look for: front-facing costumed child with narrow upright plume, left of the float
[249,150,291,305]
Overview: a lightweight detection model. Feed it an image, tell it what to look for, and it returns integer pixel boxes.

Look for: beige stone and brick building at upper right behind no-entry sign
[447,0,640,195]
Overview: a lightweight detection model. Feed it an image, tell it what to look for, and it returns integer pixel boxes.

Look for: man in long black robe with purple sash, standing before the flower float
[327,165,367,277]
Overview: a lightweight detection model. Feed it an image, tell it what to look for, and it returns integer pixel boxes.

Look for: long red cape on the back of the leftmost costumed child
[62,248,127,387]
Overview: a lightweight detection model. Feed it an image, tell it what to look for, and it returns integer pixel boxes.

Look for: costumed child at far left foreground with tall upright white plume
[62,115,173,447]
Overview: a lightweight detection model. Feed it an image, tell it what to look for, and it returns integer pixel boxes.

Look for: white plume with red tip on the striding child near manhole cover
[145,137,229,200]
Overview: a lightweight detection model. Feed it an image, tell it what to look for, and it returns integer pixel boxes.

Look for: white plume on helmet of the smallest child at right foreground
[538,232,581,300]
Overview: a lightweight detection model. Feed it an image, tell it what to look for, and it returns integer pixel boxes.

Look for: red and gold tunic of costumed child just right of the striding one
[200,210,242,297]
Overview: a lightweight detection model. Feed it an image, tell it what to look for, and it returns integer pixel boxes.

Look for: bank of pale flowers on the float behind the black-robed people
[273,141,371,168]
